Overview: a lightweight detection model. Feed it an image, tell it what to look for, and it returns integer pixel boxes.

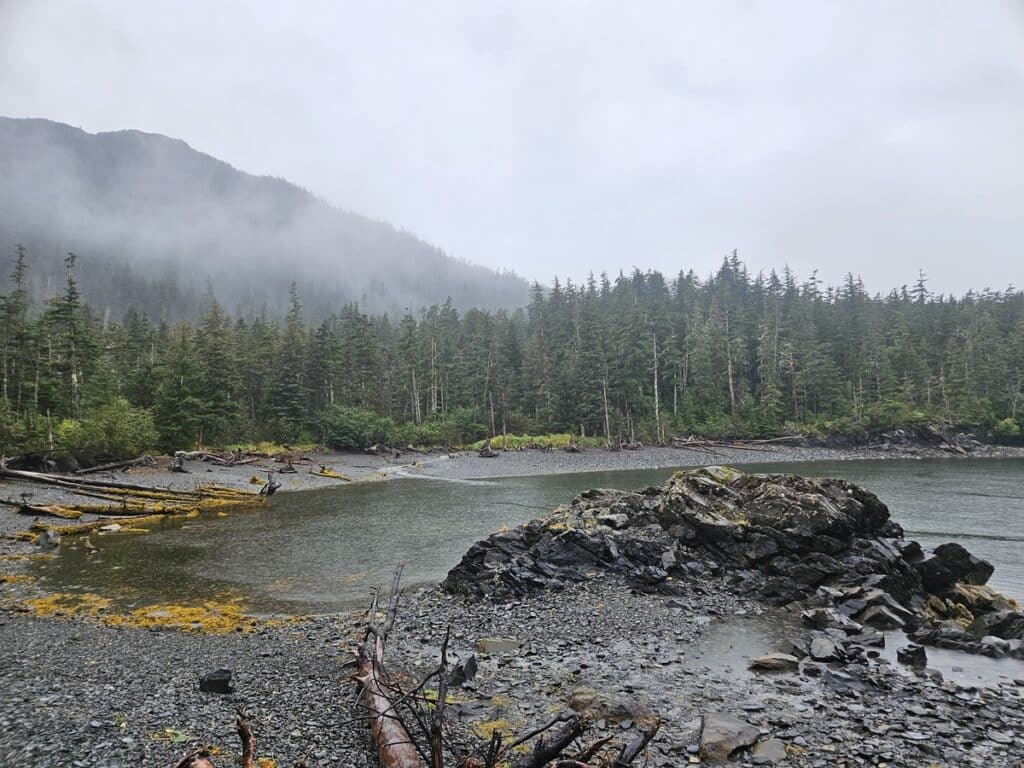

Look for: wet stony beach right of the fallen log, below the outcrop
[389,572,1024,768]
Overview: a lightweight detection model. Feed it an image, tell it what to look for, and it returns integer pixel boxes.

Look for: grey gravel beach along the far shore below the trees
[0,443,1024,578]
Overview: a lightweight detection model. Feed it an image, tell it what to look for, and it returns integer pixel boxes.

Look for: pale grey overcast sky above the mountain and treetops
[0,0,1024,293]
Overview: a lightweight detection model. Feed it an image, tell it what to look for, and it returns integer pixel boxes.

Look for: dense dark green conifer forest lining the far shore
[0,247,1024,460]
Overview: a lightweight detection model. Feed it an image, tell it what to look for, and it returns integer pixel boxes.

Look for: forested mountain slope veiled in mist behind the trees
[0,118,527,319]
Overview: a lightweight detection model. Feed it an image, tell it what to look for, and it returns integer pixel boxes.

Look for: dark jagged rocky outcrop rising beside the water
[443,467,1024,658]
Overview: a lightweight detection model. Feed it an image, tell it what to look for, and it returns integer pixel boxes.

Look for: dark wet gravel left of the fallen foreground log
[0,613,373,768]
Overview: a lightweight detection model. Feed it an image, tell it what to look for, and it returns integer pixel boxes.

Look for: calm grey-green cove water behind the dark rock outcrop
[37,459,1024,612]
